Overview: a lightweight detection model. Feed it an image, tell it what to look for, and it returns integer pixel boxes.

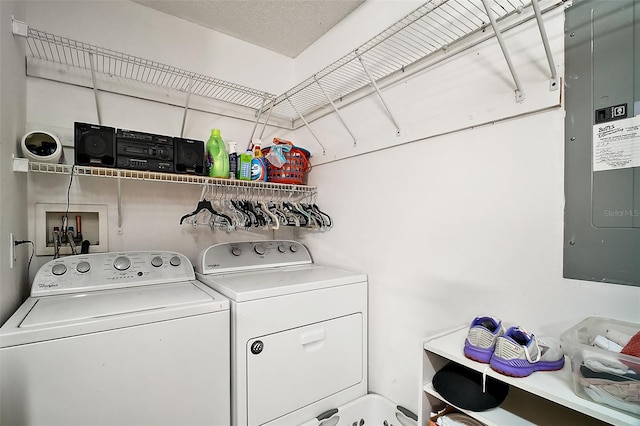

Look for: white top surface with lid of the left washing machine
[0,280,229,348]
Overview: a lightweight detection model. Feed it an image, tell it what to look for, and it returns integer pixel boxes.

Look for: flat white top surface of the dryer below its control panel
[196,265,367,302]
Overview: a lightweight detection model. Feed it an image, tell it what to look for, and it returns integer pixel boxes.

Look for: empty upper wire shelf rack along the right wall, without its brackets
[269,0,530,119]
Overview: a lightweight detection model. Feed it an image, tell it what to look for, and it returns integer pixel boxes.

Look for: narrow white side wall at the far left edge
[0,1,30,324]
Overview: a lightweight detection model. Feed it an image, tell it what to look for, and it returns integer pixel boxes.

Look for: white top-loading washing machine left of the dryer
[0,251,230,426]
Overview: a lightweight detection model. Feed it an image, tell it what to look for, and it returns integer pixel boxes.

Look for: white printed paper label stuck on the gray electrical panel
[592,112,640,172]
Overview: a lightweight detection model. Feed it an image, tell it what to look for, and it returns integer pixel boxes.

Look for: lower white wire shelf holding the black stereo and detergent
[28,161,318,201]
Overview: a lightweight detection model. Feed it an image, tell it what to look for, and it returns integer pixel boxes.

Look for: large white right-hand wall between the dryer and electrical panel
[296,0,640,416]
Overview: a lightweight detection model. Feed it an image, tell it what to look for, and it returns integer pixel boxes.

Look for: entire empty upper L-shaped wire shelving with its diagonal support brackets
[13,0,567,148]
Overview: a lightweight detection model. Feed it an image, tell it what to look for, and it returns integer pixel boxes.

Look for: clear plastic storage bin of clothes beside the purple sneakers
[560,317,640,424]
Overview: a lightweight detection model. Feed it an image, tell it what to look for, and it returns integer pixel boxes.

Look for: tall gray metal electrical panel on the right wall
[564,0,640,286]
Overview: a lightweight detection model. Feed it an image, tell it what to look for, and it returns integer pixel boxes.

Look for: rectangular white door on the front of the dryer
[246,313,364,425]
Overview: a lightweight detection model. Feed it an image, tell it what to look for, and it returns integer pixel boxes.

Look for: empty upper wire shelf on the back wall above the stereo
[27,28,275,110]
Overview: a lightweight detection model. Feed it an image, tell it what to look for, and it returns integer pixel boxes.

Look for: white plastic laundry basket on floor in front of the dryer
[300,393,418,426]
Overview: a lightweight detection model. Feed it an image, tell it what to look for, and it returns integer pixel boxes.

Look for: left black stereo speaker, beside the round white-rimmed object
[73,123,116,167]
